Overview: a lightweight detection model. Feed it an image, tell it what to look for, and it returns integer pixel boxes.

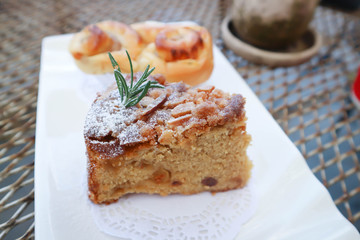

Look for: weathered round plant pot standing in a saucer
[232,0,319,49]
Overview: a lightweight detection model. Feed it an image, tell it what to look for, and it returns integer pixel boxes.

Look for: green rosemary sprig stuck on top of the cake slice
[109,51,164,107]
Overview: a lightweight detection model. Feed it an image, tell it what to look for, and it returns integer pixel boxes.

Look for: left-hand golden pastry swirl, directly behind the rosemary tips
[69,21,142,74]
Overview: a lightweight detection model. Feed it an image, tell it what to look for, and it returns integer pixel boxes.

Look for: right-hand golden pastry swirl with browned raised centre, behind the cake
[131,21,213,85]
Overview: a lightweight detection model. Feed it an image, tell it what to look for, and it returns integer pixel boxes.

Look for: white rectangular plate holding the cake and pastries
[35,35,360,240]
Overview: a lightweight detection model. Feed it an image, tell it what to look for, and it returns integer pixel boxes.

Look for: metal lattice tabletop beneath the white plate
[0,0,360,239]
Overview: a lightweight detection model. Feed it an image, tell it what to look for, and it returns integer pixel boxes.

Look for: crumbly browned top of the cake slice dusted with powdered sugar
[84,73,245,157]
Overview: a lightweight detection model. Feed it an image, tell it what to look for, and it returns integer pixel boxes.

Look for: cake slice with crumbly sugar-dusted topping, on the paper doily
[84,73,252,203]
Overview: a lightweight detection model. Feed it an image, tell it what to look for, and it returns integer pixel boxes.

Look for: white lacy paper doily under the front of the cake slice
[89,183,257,240]
